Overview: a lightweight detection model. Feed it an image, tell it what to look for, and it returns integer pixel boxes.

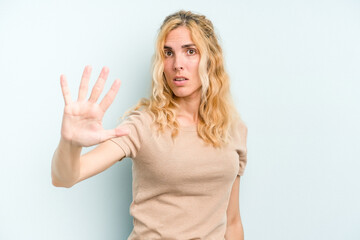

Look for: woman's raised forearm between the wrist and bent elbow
[51,138,82,187]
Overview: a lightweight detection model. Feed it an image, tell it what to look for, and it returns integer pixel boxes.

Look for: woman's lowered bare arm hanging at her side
[225,176,244,240]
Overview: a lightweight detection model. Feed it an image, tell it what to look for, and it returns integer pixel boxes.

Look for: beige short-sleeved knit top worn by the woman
[112,111,246,240]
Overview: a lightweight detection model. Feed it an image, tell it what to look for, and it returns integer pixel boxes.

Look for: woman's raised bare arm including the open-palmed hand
[51,66,128,187]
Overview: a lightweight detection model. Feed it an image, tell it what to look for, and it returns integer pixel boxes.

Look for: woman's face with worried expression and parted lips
[164,26,201,100]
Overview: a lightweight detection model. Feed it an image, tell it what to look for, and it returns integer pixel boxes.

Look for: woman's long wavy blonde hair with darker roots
[133,10,238,147]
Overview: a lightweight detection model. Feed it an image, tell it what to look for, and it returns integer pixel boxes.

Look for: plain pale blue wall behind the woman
[0,0,360,240]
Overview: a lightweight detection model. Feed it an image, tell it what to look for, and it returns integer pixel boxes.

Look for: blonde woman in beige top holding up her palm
[52,11,247,239]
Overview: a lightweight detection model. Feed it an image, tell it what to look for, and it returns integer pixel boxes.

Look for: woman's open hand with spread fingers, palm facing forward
[60,66,129,147]
